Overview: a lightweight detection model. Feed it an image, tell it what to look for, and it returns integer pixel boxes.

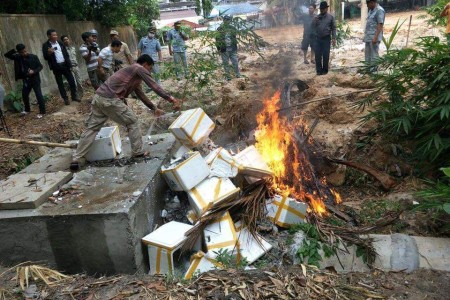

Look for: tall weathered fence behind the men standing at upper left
[0,14,138,96]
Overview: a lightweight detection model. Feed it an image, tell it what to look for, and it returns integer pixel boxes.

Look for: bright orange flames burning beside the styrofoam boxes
[255,92,341,216]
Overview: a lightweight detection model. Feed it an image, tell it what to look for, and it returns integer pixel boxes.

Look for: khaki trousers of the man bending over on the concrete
[74,95,144,161]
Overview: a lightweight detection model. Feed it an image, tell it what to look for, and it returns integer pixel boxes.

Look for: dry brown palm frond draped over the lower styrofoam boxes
[182,180,268,251]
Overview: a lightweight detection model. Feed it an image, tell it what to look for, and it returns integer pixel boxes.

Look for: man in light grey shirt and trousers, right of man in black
[364,0,385,64]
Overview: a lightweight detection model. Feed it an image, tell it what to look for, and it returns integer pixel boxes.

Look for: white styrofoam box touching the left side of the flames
[234,145,273,183]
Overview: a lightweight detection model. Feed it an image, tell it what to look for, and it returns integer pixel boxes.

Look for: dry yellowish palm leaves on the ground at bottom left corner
[16,265,70,290]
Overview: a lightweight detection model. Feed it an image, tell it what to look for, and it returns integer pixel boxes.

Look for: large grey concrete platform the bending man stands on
[0,134,175,275]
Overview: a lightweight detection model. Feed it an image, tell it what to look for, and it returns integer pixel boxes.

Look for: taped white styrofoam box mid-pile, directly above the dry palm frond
[188,177,241,215]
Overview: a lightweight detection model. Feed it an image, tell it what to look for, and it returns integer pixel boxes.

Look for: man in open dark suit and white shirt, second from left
[42,29,80,105]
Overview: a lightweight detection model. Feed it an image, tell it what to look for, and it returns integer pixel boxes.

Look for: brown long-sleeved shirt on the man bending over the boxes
[95,63,171,109]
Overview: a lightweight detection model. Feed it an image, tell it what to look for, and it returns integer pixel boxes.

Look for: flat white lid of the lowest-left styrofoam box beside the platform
[142,221,193,248]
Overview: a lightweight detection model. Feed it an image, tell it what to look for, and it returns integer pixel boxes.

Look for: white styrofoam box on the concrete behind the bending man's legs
[86,126,122,161]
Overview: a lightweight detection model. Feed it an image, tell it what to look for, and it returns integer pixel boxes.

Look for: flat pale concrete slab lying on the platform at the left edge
[0,172,72,210]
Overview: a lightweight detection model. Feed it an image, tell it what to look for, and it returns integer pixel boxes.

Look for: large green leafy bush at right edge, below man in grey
[358,37,450,171]
